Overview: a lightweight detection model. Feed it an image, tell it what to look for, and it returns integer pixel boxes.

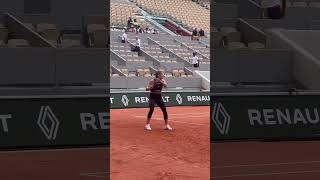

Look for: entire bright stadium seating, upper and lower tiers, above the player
[110,0,210,91]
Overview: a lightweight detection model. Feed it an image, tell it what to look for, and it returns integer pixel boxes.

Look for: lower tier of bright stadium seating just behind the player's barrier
[110,31,209,90]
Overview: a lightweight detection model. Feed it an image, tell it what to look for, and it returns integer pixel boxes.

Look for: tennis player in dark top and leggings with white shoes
[145,71,172,131]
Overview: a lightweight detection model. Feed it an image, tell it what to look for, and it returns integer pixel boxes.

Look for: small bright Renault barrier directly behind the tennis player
[110,92,210,109]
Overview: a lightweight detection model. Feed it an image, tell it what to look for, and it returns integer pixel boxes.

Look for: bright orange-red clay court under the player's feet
[110,106,210,180]
